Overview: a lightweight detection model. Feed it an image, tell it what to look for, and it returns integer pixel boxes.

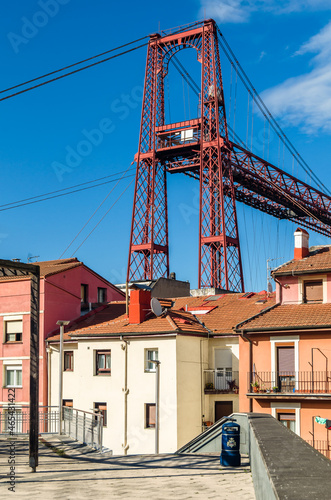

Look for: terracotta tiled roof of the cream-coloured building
[48,292,275,342]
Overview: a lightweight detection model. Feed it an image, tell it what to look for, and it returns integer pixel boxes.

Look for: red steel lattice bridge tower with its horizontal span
[127,20,331,291]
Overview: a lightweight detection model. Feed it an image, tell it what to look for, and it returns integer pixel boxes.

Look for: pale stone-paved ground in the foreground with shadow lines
[0,437,255,500]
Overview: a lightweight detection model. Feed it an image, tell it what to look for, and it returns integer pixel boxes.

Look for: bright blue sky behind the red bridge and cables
[0,0,331,290]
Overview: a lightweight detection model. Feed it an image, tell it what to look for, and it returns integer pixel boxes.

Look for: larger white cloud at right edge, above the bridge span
[262,22,331,134]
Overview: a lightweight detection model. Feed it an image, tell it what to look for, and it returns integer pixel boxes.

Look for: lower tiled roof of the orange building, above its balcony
[237,304,331,332]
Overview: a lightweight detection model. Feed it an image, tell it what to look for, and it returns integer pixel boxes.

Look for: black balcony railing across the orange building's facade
[247,371,331,394]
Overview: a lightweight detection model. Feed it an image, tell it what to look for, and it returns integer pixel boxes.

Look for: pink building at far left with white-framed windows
[0,258,124,420]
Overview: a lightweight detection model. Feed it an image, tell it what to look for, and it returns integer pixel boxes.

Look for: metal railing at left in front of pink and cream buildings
[0,404,103,450]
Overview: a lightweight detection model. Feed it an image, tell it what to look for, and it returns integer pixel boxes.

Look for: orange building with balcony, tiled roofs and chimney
[235,228,331,458]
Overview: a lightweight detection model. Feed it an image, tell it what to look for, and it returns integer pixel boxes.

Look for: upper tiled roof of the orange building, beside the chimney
[272,246,331,276]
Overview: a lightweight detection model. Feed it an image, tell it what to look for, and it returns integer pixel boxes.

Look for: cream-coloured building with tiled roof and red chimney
[47,290,274,455]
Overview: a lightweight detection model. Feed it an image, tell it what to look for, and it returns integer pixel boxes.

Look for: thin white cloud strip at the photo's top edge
[200,0,331,23]
